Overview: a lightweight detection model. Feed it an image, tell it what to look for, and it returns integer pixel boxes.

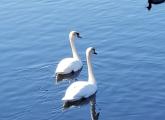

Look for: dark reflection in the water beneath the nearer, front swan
[63,94,100,120]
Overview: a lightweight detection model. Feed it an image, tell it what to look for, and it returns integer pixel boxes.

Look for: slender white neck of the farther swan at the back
[69,35,80,60]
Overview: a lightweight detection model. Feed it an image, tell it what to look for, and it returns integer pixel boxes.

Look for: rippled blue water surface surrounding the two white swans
[0,0,165,120]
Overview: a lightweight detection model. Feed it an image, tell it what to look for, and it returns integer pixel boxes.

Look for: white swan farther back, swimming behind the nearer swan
[55,31,83,79]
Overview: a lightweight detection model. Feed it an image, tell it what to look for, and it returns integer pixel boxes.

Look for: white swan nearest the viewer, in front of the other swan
[62,47,97,101]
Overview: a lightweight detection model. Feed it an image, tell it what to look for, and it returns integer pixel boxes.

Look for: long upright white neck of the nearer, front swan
[86,52,96,84]
